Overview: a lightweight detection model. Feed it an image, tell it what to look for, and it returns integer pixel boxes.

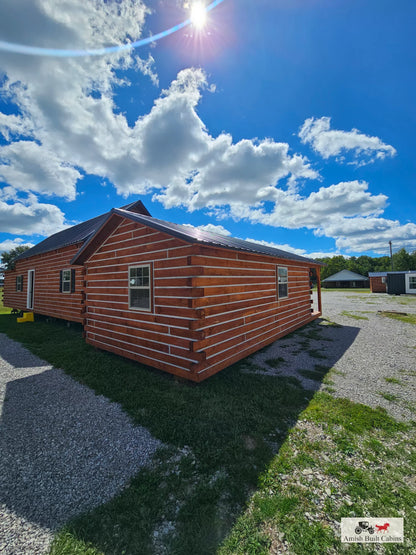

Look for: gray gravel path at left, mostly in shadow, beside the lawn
[0,334,161,555]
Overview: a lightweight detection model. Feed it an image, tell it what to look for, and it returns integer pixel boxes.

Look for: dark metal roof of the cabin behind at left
[16,201,150,260]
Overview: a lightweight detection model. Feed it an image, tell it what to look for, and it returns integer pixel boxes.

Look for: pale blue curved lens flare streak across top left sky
[0,0,224,58]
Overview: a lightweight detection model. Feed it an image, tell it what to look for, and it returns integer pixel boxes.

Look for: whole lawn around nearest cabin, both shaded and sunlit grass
[0,315,416,555]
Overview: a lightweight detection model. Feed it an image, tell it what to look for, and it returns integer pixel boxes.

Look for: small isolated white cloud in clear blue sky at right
[299,117,396,165]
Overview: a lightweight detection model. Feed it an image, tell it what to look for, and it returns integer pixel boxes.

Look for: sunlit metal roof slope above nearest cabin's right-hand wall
[101,208,321,265]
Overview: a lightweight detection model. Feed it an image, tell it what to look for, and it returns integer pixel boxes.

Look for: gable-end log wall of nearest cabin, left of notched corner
[85,220,205,379]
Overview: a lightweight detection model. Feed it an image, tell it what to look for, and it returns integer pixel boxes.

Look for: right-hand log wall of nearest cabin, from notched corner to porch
[184,247,319,381]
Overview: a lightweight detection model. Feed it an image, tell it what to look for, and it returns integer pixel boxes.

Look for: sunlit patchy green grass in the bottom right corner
[219,393,416,555]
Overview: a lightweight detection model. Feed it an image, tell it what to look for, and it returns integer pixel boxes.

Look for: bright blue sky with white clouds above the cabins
[0,0,416,256]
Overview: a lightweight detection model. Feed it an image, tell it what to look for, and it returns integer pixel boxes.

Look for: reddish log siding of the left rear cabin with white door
[3,243,84,323]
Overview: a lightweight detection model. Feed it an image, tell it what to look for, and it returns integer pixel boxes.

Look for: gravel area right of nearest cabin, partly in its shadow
[247,291,416,420]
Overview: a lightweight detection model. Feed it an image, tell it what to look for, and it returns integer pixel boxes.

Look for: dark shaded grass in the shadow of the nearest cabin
[0,316,356,555]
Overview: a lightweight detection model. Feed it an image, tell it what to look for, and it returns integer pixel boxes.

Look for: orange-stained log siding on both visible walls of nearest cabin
[84,219,320,381]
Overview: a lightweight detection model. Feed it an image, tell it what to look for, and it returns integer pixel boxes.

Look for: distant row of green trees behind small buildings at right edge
[316,249,416,279]
